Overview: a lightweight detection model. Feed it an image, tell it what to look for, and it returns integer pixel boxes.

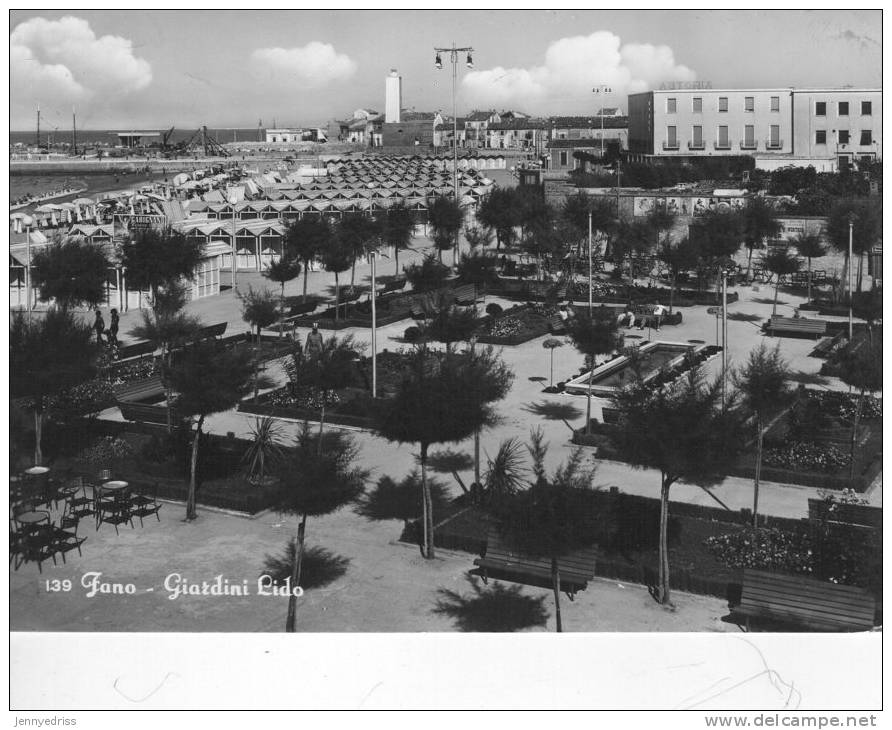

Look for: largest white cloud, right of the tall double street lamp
[462,31,697,113]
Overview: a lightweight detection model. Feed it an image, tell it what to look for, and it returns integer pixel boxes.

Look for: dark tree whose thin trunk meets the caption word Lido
[275,429,369,633]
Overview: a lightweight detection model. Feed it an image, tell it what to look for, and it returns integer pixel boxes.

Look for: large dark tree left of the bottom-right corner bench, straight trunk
[613,367,741,604]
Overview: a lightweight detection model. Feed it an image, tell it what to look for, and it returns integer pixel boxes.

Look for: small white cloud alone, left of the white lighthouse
[251,41,357,88]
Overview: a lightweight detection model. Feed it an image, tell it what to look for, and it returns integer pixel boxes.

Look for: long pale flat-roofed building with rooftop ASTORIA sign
[628,88,882,170]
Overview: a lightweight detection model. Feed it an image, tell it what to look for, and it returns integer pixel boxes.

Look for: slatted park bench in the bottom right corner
[723,568,876,631]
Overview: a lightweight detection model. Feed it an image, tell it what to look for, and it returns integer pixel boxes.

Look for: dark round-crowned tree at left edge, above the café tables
[9,307,98,466]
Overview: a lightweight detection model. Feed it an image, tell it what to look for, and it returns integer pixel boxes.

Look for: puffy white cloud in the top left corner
[9,16,152,102]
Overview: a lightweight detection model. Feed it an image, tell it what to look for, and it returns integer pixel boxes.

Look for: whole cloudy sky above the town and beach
[9,10,882,130]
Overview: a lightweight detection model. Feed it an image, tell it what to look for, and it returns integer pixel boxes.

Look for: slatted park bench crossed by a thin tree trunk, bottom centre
[471,529,596,600]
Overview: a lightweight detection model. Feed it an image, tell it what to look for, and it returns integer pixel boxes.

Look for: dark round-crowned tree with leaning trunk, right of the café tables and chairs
[170,342,257,521]
